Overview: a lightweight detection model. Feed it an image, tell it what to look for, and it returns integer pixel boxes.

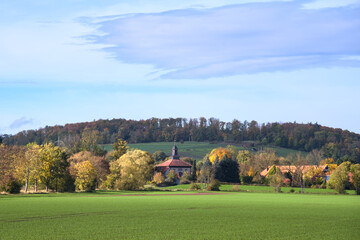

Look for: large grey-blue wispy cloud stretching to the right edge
[86,1,360,79]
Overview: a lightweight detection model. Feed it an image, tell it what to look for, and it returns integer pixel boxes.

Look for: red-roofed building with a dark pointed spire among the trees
[155,144,192,181]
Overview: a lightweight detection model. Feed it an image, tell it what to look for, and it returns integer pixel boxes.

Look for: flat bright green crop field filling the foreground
[0,191,360,239]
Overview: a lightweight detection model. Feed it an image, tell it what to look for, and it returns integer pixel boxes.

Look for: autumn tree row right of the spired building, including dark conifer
[194,146,360,194]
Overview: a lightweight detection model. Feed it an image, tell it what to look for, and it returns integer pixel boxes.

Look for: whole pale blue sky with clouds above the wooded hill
[0,0,360,135]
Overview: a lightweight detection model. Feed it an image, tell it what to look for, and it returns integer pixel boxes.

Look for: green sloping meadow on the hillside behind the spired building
[101,142,304,160]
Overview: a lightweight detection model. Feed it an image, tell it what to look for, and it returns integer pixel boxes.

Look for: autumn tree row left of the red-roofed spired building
[0,140,154,192]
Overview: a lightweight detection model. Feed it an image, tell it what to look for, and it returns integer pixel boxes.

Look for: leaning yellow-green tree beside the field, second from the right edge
[328,162,351,193]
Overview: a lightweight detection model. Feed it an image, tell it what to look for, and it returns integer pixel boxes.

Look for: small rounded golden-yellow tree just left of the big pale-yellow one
[75,161,96,191]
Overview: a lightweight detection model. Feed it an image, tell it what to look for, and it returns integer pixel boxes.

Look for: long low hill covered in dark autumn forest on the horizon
[0,117,360,162]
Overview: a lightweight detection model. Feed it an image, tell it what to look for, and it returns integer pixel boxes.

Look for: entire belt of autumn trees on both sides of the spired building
[0,139,360,194]
